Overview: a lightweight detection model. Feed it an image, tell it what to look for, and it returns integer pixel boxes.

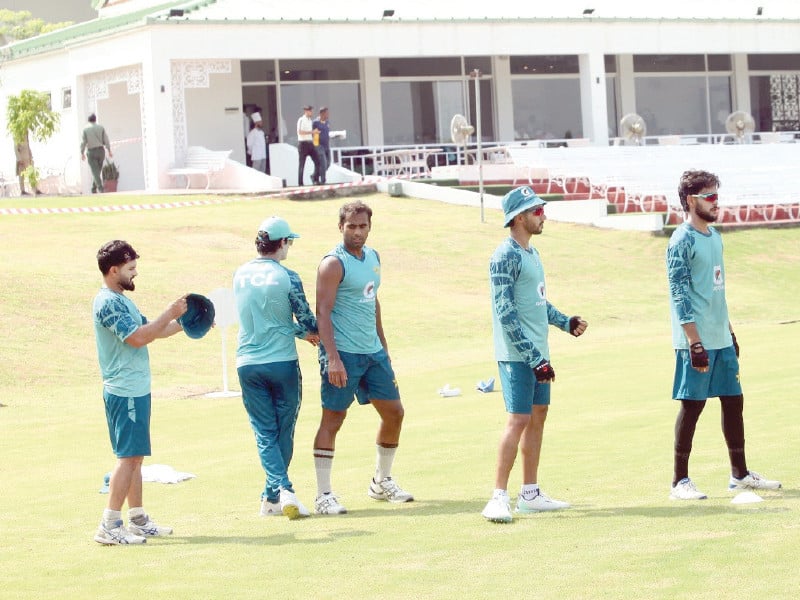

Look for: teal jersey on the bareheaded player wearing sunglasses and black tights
[667,223,733,350]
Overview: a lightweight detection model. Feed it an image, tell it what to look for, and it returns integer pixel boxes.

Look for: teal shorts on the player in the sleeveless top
[319,350,400,411]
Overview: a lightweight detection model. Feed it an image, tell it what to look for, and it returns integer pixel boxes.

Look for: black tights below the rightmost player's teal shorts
[672,394,747,485]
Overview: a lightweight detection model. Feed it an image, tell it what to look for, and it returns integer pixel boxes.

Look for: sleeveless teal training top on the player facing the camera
[327,244,383,354]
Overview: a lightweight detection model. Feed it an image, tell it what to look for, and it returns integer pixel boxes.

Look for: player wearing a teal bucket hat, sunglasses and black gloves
[482,186,587,523]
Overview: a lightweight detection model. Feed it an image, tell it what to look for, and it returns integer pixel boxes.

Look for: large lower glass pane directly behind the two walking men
[280,83,363,148]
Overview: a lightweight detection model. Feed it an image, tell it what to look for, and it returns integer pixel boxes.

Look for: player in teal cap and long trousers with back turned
[233,217,319,519]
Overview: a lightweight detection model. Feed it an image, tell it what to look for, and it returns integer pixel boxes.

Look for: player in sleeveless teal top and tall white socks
[314,201,414,515]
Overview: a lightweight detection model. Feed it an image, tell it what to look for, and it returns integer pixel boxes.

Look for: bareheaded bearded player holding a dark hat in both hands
[92,240,187,545]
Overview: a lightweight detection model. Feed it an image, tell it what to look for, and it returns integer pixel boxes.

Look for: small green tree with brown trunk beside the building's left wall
[6,90,60,191]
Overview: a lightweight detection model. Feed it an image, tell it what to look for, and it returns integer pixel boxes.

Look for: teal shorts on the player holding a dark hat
[103,391,150,458]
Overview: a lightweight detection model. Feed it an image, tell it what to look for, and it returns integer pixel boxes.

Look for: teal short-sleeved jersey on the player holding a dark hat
[92,287,150,398]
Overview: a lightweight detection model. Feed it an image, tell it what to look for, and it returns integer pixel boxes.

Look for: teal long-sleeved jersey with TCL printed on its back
[233,258,317,367]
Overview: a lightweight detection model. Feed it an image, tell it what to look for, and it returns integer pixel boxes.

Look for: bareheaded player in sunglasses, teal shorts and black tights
[667,171,781,500]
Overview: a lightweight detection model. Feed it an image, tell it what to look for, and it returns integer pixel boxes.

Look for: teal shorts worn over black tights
[672,346,742,400]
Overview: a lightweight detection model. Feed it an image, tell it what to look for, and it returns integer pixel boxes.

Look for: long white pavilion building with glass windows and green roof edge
[0,0,800,191]
